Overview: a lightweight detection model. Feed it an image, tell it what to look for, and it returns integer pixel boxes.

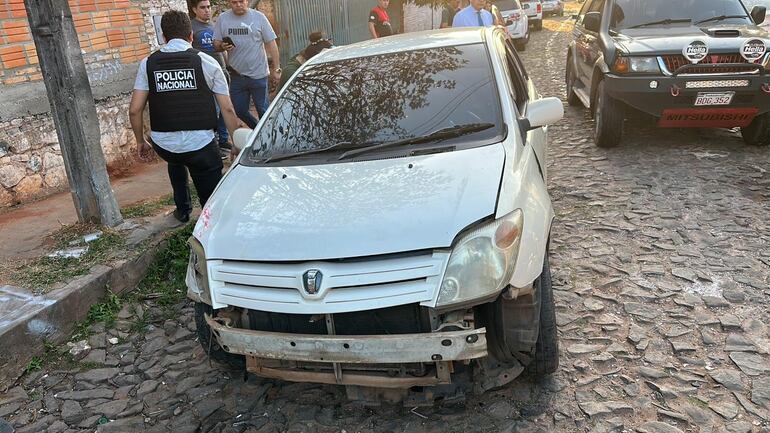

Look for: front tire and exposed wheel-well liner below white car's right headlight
[477,254,559,376]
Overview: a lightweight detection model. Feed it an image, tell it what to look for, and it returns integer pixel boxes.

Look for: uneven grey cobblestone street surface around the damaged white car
[0,17,770,433]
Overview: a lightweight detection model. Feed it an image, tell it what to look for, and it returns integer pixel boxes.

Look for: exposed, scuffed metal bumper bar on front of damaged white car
[205,315,487,388]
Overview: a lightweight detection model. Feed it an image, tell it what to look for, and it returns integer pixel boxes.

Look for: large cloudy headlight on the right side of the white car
[436,209,524,307]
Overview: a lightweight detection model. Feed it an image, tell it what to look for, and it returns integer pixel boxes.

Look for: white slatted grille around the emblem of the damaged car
[209,252,448,314]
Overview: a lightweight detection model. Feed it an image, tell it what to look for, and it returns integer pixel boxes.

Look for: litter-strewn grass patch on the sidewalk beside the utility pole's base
[10,224,125,294]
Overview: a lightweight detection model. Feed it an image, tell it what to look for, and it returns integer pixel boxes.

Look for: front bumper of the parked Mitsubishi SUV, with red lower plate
[604,74,770,127]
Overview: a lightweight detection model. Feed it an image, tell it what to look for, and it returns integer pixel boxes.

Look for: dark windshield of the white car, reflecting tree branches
[241,44,505,165]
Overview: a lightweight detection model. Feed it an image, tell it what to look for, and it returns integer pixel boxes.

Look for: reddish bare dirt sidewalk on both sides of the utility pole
[0,161,171,261]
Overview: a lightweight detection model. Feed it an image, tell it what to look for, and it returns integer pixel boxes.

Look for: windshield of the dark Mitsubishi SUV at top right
[610,0,751,30]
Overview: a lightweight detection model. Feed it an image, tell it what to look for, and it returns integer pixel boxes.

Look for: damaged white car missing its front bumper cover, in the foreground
[187,27,563,396]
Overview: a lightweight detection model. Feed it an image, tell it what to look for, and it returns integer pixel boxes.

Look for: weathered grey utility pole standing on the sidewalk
[24,0,123,227]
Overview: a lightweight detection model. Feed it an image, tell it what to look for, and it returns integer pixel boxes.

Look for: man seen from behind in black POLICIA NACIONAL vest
[129,11,238,222]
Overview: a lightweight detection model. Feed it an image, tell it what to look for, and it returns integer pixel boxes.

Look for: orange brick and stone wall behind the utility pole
[0,0,187,208]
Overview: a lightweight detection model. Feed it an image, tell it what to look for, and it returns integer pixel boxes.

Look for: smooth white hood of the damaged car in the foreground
[194,144,505,261]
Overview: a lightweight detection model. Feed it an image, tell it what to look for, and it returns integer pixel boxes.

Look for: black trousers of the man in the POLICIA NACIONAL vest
[151,139,223,214]
